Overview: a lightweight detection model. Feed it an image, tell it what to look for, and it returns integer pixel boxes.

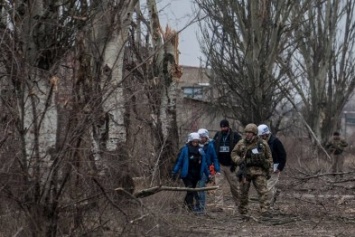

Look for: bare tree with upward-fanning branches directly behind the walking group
[196,0,302,125]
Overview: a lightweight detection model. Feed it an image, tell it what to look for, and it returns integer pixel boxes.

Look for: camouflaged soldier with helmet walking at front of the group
[231,123,272,215]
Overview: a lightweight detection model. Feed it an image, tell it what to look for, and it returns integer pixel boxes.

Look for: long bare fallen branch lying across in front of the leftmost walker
[115,186,219,198]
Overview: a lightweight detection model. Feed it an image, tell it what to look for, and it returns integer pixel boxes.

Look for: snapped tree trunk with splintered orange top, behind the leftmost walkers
[147,0,182,183]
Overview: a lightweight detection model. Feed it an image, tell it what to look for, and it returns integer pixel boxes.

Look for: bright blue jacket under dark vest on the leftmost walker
[173,144,210,179]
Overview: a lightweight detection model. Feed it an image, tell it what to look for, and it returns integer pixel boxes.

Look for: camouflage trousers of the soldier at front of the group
[238,175,270,214]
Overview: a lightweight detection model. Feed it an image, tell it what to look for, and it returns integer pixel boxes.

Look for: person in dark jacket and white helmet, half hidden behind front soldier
[258,124,287,207]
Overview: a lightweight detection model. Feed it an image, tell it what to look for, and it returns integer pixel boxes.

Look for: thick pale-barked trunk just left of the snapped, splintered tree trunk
[90,0,138,157]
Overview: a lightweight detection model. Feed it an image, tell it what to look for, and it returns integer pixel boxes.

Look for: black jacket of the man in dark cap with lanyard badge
[213,129,242,166]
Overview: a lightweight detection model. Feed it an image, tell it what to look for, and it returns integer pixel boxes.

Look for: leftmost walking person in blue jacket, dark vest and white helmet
[172,132,210,212]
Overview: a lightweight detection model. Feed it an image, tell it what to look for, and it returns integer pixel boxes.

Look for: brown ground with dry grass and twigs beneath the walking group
[0,140,355,237]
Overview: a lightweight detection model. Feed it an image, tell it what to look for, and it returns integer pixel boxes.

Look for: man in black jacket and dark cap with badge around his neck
[213,119,241,211]
